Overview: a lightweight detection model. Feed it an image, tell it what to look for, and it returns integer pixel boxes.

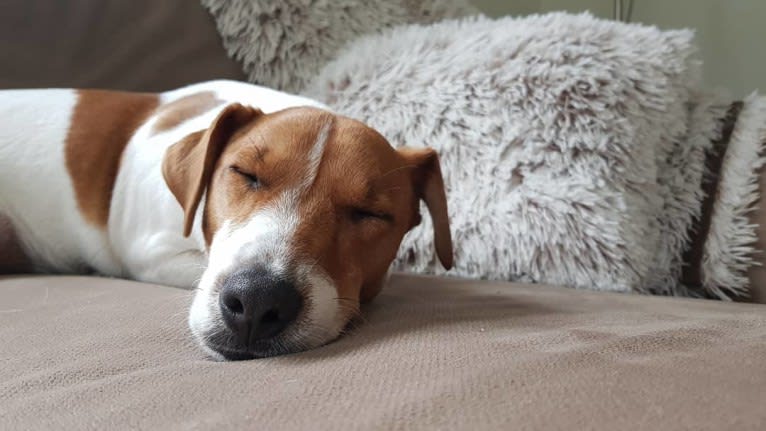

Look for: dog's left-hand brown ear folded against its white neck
[162,103,263,236]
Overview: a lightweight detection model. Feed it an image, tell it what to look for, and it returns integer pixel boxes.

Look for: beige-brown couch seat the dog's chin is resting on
[0,276,766,430]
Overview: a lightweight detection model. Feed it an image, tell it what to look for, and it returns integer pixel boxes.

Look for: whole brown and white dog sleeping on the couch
[0,81,451,357]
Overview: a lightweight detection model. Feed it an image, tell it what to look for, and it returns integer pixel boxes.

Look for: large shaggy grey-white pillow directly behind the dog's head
[306,13,699,291]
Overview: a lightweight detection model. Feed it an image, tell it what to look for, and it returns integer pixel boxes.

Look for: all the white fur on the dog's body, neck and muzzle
[0,81,342,354]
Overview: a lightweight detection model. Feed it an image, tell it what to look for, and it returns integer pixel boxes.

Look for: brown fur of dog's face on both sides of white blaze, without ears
[203,108,426,315]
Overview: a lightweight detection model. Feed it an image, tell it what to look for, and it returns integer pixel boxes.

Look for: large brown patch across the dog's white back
[66,90,158,227]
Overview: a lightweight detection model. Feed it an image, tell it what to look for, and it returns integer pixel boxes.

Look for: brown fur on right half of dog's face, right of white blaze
[292,118,418,306]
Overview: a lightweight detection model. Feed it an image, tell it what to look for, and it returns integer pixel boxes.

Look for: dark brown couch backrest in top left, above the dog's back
[0,0,244,91]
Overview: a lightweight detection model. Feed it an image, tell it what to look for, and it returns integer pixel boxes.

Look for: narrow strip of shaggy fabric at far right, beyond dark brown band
[702,94,766,299]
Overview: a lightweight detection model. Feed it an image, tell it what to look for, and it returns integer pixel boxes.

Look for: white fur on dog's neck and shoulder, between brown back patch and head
[109,81,323,288]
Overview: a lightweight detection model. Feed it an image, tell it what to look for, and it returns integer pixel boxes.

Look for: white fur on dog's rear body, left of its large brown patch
[0,89,123,275]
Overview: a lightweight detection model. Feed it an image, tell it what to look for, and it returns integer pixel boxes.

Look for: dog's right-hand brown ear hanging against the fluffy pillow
[399,148,453,269]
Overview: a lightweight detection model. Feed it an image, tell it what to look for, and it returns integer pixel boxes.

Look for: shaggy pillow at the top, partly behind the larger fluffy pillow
[202,0,478,92]
